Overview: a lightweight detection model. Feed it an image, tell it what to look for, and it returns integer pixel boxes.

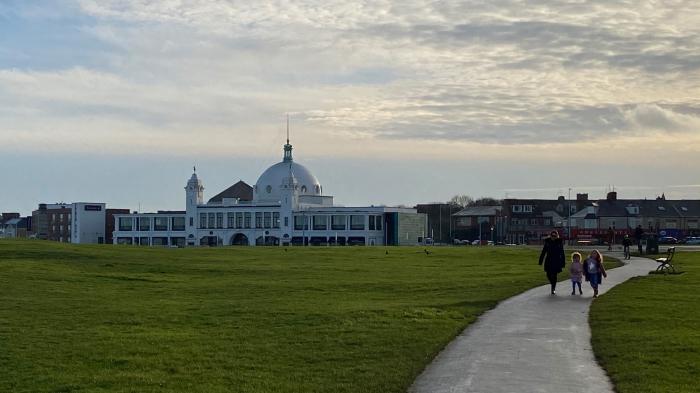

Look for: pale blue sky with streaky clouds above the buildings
[0,0,700,214]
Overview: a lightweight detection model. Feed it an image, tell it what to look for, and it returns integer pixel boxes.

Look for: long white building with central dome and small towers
[114,141,427,247]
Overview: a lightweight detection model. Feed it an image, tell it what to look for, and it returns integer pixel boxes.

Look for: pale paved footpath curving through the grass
[409,253,657,393]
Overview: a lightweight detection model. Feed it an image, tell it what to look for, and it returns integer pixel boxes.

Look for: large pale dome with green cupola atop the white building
[253,144,323,202]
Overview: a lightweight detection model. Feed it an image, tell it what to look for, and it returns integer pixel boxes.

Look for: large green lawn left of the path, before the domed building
[0,241,565,392]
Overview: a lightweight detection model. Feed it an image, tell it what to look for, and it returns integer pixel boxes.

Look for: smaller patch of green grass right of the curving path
[590,252,700,393]
